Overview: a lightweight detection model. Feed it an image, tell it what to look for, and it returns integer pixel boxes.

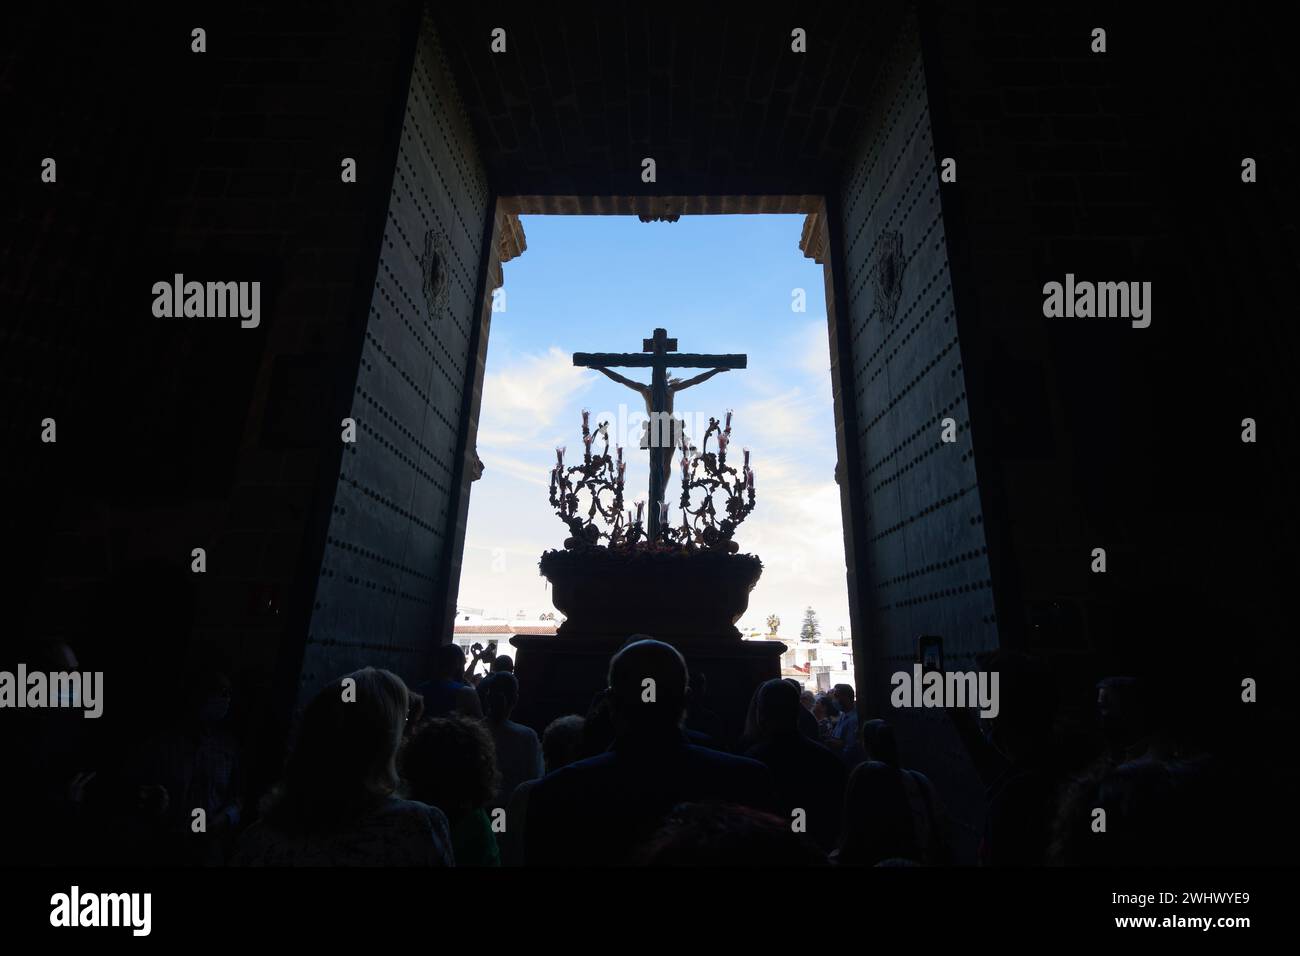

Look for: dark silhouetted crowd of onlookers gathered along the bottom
[5,635,1288,866]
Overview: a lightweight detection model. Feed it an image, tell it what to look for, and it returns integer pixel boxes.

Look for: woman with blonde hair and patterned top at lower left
[233,667,452,866]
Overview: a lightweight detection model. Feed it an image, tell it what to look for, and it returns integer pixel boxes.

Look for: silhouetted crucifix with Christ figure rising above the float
[573,329,748,541]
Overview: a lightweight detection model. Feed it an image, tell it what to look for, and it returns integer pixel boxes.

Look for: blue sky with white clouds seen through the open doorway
[458,216,849,637]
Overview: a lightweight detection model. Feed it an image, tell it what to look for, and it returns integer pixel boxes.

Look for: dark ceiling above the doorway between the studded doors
[430,0,901,195]
